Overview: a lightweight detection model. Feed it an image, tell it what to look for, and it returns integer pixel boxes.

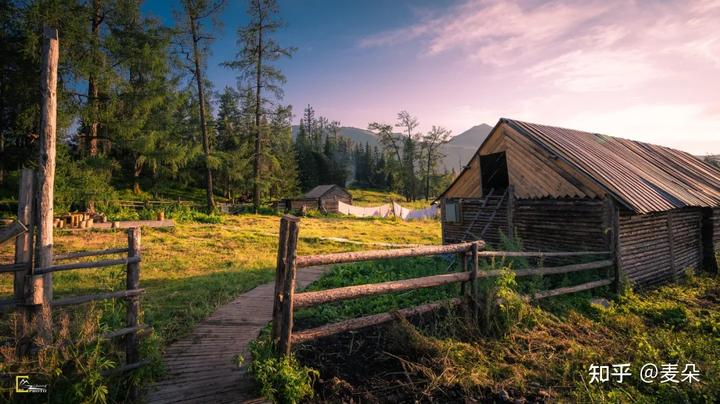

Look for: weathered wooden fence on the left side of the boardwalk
[0,169,150,397]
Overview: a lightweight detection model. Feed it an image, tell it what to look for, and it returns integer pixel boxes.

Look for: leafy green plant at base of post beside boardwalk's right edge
[248,338,320,403]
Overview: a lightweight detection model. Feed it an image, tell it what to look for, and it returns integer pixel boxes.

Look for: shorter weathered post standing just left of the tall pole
[13,168,35,350]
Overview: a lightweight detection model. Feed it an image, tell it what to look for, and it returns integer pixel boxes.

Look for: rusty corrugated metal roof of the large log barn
[498,118,720,213]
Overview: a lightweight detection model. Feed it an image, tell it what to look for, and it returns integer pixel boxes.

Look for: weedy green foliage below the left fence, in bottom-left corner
[0,301,159,403]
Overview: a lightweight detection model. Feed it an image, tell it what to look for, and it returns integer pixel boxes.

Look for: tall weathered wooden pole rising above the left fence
[32,27,60,338]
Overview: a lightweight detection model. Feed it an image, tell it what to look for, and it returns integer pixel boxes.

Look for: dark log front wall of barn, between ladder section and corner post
[513,198,609,251]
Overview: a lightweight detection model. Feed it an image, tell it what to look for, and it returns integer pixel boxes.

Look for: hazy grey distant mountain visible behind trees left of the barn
[292,123,492,173]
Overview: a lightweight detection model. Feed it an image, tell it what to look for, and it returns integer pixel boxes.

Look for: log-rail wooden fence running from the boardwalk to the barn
[272,215,614,355]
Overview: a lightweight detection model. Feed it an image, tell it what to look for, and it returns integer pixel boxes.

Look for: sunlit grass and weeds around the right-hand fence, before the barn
[296,252,720,403]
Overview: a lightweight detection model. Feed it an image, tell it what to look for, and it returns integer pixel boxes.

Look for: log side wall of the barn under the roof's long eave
[619,208,702,288]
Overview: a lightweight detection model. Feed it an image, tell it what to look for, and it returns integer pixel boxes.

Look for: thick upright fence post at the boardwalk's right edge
[278,215,300,355]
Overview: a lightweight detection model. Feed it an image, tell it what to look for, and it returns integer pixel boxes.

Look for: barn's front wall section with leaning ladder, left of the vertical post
[441,194,508,246]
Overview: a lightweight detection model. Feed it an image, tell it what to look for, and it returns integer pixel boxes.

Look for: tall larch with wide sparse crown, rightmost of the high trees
[224,0,295,213]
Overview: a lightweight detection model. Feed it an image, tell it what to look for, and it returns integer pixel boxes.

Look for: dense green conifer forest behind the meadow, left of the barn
[0,0,450,210]
